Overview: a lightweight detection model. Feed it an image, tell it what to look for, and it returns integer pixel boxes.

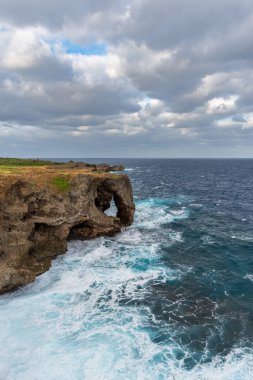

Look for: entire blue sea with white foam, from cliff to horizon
[0,159,253,380]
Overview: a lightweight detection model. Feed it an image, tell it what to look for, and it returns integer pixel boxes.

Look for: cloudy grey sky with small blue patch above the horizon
[0,0,253,158]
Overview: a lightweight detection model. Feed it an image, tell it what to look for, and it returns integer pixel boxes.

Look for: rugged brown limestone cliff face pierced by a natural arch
[0,173,134,293]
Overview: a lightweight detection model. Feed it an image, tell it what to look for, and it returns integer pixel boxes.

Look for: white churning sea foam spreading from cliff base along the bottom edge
[0,200,253,380]
